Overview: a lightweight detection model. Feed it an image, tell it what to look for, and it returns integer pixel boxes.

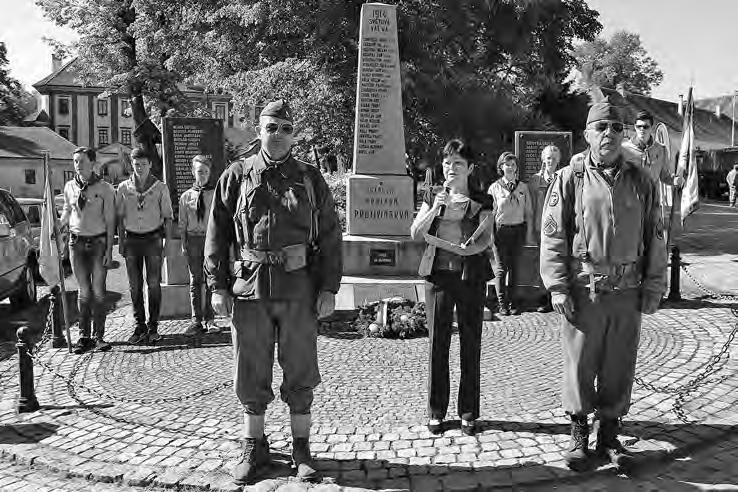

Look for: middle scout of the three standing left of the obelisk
[116,148,173,343]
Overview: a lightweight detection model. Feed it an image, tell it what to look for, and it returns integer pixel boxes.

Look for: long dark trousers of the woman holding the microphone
[425,271,485,420]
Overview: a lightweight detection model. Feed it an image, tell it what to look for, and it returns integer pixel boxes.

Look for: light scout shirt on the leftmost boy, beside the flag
[62,179,115,236]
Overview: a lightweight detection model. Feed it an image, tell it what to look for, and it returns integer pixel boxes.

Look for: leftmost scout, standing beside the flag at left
[60,147,115,354]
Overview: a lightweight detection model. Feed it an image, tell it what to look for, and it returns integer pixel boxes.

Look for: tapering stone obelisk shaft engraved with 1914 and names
[354,3,405,174]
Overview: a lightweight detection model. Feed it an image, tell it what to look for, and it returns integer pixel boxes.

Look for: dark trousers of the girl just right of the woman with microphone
[493,222,526,305]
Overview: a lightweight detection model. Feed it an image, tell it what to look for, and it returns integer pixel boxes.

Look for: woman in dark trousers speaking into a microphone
[410,140,492,435]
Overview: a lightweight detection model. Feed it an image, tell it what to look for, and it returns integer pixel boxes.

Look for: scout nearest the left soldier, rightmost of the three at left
[179,155,220,336]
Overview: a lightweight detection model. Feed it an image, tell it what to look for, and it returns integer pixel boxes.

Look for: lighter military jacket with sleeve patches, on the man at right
[540,151,666,297]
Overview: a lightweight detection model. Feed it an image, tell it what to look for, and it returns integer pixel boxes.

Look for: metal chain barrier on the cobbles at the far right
[634,264,738,423]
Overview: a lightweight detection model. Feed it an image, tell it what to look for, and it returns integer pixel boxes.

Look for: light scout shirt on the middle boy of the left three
[116,176,174,234]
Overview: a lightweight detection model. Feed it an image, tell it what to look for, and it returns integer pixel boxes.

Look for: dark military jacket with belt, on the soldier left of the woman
[204,152,343,300]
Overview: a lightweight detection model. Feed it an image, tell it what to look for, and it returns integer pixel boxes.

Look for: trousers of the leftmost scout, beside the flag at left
[69,234,108,339]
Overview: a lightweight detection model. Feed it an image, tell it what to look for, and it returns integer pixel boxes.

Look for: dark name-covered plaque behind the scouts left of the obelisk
[163,118,225,213]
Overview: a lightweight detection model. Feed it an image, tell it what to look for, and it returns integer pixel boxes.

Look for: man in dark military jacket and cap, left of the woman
[205,101,343,484]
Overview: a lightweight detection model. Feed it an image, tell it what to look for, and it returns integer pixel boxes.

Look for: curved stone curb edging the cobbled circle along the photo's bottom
[0,425,738,492]
